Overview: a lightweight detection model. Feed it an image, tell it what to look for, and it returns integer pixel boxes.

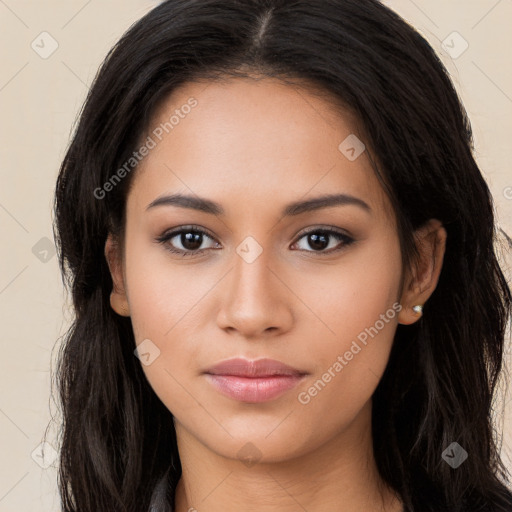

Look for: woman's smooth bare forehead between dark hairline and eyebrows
[129,78,390,221]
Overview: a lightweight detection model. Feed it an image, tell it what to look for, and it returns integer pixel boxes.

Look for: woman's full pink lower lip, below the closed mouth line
[206,373,304,402]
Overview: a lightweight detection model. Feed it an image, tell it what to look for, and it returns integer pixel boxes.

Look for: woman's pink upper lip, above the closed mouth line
[205,357,306,377]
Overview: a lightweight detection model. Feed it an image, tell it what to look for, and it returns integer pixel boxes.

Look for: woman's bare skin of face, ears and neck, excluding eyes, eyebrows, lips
[105,78,446,512]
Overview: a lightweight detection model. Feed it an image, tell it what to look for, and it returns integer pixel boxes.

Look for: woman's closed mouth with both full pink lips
[205,358,307,403]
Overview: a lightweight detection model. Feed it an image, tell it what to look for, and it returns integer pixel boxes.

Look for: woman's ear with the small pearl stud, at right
[398,219,447,325]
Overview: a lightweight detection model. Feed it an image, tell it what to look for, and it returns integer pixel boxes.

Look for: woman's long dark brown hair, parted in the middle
[54,0,512,512]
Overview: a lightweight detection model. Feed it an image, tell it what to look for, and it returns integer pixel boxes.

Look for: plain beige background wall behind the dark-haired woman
[0,0,512,512]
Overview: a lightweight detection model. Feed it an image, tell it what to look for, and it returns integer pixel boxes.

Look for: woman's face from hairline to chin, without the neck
[111,79,428,462]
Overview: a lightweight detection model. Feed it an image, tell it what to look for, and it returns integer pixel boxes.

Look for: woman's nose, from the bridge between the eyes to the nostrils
[217,244,294,339]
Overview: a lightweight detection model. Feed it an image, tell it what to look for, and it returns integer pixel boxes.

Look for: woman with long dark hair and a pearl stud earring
[51,0,512,512]
